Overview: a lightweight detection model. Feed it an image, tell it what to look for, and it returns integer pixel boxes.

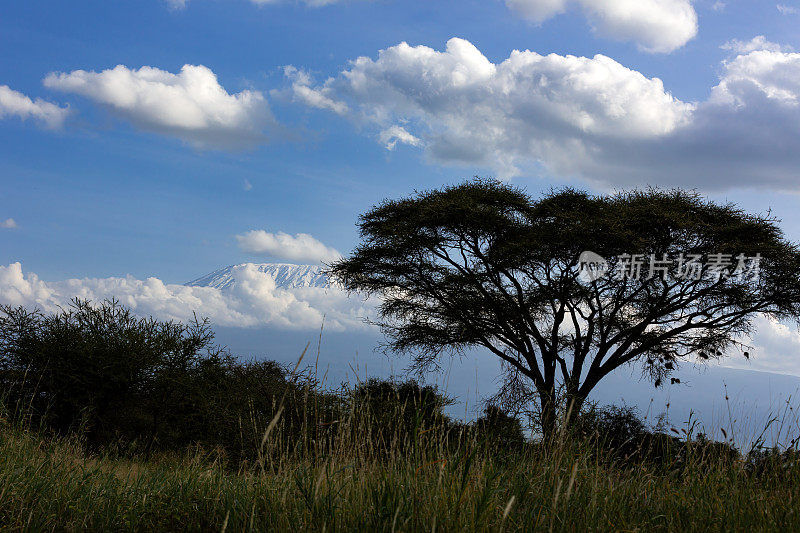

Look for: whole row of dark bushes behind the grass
[0,300,752,471]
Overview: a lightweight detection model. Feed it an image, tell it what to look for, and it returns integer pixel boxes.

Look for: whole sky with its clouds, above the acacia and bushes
[0,0,800,374]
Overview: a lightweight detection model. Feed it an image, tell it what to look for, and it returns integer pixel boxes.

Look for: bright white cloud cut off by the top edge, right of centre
[506,0,697,53]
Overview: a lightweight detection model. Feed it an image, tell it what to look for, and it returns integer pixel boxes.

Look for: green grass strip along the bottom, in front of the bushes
[0,418,800,531]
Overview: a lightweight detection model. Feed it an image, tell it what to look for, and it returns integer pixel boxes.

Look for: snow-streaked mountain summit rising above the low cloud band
[186,263,329,289]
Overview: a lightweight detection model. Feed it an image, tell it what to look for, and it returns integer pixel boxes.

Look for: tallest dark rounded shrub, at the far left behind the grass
[0,299,222,445]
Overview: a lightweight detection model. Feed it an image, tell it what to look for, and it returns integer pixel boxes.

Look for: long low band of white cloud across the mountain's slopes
[0,263,372,331]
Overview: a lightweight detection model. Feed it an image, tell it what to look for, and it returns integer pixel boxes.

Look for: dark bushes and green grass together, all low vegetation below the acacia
[0,300,800,531]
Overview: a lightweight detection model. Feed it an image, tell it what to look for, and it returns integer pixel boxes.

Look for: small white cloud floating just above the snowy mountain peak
[236,230,342,264]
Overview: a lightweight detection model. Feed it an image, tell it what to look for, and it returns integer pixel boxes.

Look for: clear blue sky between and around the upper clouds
[0,0,800,282]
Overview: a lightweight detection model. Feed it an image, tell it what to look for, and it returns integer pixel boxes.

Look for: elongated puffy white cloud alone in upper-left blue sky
[44,65,278,148]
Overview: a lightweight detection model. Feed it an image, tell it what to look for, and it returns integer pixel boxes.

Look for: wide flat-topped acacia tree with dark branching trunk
[329,180,800,436]
